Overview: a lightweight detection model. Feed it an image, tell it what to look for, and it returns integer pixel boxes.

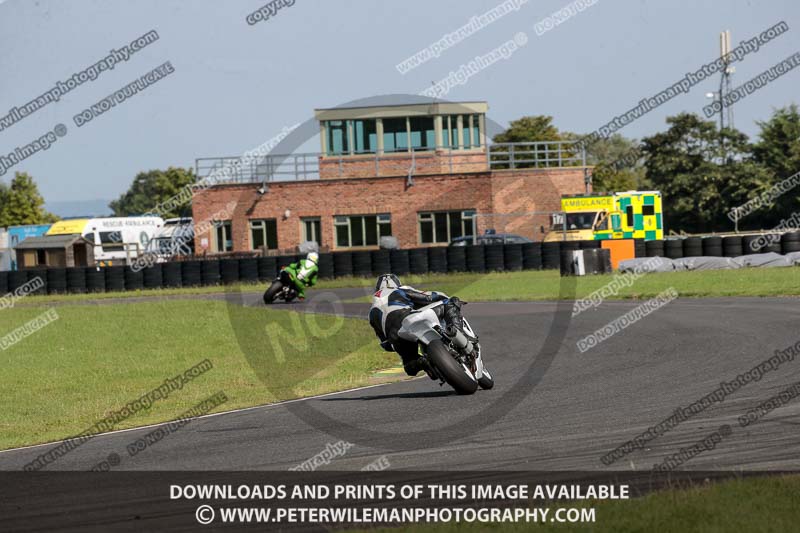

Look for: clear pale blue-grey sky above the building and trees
[0,0,800,211]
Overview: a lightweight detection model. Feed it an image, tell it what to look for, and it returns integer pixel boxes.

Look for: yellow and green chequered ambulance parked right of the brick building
[544,191,664,242]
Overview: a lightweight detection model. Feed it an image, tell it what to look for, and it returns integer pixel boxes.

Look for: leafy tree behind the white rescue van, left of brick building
[108,167,195,218]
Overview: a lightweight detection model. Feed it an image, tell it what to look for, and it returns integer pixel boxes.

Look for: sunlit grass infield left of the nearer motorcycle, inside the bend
[0,300,399,449]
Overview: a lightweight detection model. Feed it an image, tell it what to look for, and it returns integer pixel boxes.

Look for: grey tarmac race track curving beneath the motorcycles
[0,289,800,471]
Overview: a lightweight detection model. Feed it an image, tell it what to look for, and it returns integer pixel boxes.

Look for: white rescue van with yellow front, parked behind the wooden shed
[47,217,164,266]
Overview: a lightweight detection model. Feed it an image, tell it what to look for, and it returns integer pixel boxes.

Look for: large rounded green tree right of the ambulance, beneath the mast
[642,113,770,232]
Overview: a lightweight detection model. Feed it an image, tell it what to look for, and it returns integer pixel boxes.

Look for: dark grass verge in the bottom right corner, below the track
[372,475,800,533]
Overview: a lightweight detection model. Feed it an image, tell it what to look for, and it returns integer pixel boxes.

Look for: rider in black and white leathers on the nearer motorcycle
[369,274,464,376]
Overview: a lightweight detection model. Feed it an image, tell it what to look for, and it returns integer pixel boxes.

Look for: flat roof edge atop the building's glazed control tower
[314,100,489,120]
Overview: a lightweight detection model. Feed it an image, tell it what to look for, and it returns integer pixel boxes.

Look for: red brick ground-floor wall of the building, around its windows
[192,168,584,253]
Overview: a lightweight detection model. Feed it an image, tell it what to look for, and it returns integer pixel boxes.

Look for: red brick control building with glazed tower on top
[192,102,588,254]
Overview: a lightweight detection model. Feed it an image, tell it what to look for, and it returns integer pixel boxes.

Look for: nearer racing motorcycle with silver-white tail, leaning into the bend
[397,301,494,394]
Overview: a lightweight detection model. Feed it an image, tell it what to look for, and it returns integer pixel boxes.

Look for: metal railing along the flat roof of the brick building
[195,141,586,183]
